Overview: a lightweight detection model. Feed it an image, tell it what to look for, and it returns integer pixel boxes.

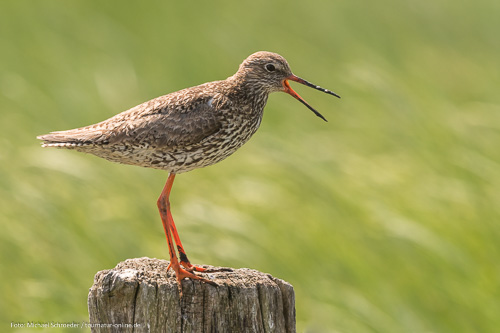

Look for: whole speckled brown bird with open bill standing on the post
[37,51,340,295]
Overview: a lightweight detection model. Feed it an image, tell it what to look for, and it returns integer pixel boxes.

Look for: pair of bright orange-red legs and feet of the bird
[157,173,213,294]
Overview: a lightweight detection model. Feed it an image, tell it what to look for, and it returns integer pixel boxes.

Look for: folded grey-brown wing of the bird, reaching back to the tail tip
[38,90,222,148]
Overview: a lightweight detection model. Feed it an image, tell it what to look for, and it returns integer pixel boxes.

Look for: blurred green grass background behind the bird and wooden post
[0,0,500,332]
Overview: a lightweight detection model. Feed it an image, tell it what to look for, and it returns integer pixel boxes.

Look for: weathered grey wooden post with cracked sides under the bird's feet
[88,258,295,333]
